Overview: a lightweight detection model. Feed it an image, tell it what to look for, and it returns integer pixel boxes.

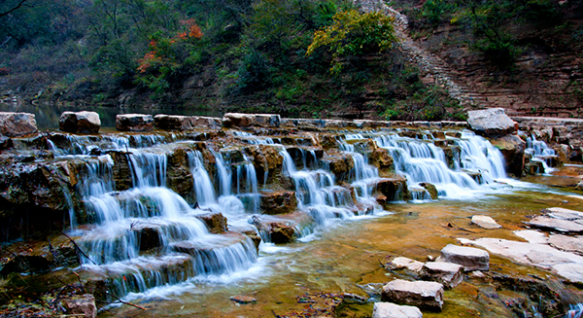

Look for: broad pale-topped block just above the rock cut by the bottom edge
[381,279,443,311]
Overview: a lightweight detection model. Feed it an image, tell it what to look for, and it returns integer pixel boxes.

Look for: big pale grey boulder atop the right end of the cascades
[468,108,518,137]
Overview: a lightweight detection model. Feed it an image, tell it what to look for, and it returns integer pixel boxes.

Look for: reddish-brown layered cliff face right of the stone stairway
[396,1,583,118]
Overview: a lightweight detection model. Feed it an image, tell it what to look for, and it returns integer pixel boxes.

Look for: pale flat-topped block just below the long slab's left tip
[437,244,490,272]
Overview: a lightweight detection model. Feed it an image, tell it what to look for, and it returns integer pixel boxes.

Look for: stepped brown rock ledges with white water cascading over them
[0,112,580,318]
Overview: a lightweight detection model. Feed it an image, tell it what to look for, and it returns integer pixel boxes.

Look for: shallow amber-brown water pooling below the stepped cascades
[103,175,583,317]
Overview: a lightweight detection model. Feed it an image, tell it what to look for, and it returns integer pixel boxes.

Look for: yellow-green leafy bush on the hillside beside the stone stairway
[306,10,397,74]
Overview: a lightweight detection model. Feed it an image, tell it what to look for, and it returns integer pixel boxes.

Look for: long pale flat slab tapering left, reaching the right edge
[458,238,583,282]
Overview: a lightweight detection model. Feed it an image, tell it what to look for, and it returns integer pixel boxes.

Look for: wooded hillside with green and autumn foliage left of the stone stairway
[0,0,466,120]
